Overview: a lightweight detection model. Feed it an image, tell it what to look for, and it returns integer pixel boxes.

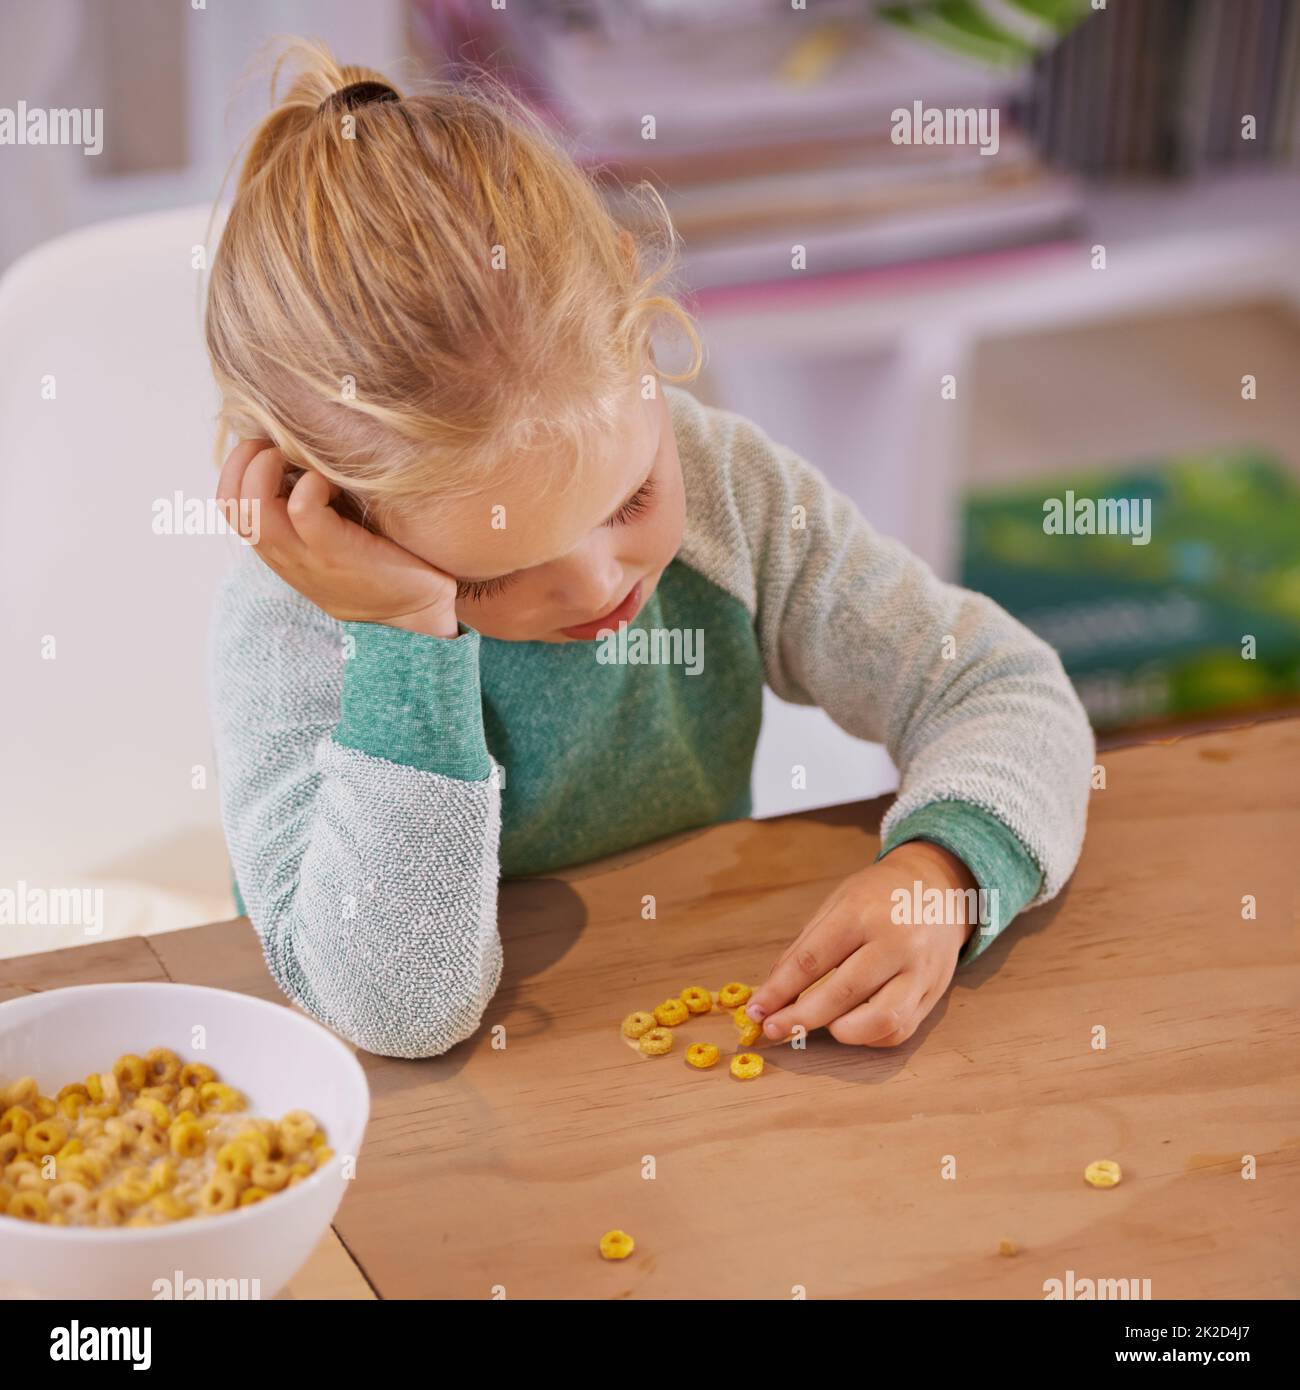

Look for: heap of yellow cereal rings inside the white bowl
[0,1048,334,1226]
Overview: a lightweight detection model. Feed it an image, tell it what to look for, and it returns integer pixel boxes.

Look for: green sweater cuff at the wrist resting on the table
[876,801,1043,966]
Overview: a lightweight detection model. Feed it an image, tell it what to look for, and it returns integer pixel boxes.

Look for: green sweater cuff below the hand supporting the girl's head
[334,623,492,781]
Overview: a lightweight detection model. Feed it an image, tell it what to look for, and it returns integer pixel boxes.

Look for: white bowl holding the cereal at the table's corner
[0,984,370,1298]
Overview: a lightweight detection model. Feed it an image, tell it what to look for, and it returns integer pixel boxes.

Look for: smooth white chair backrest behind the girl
[0,204,239,954]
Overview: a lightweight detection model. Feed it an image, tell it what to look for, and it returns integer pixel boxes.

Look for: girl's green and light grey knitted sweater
[209,386,1093,1056]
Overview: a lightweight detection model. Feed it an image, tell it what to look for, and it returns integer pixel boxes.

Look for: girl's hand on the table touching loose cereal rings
[747,841,976,1047]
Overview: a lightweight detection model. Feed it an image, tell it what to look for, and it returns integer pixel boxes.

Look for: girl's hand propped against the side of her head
[217,439,459,637]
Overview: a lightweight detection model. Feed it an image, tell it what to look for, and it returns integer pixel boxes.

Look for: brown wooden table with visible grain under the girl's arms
[0,720,1300,1298]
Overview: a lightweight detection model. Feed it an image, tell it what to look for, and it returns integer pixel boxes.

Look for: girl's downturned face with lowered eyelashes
[387,382,685,642]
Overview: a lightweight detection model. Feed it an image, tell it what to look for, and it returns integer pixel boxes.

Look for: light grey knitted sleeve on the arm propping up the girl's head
[209,549,502,1058]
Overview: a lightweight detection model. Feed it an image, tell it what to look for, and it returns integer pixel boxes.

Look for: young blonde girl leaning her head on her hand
[207,46,1093,1056]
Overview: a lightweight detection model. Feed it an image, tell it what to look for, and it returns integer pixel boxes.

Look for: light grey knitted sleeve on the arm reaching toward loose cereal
[674,393,1094,904]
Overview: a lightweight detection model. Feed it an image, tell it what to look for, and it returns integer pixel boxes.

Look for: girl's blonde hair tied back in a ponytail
[206,40,702,518]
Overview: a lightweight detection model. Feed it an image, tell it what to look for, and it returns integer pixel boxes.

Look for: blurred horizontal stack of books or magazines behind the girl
[405,0,1080,291]
